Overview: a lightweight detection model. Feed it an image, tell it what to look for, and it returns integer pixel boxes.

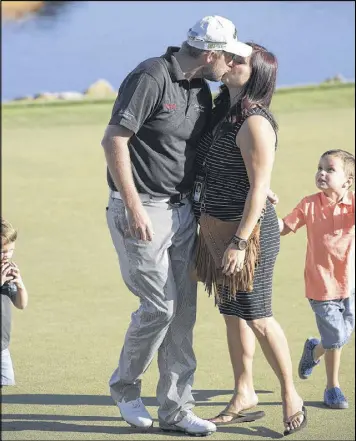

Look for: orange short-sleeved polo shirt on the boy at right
[283,191,355,300]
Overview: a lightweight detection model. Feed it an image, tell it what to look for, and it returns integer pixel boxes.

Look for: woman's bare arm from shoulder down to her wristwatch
[236,115,276,239]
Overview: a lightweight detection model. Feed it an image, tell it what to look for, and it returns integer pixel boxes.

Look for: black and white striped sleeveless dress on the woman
[193,108,280,320]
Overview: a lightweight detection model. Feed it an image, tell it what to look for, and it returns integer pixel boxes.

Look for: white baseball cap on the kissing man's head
[187,15,252,58]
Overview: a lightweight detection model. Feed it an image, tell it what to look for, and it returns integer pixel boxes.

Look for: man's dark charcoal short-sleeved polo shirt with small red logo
[107,47,212,196]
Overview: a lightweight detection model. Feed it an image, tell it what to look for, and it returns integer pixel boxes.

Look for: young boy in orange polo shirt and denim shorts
[278,150,355,409]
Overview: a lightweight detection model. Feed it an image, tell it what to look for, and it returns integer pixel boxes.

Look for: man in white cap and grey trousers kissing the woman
[102,16,251,435]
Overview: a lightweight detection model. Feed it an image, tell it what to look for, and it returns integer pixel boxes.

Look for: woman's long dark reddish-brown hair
[214,42,278,130]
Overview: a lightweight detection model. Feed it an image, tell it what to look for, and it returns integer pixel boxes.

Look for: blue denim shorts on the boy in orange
[309,290,355,349]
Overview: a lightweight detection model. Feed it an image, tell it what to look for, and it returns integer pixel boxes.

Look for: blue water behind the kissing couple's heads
[2,1,355,100]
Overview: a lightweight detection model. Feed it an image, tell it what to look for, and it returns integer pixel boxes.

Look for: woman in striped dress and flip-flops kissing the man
[193,43,307,435]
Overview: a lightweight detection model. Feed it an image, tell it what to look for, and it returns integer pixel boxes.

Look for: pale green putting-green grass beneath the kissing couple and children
[2,86,355,440]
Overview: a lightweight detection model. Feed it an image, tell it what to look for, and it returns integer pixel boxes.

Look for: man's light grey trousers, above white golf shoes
[107,195,197,424]
